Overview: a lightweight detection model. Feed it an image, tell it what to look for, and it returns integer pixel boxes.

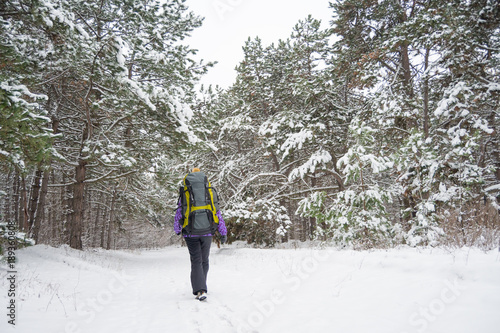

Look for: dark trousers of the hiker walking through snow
[185,236,212,295]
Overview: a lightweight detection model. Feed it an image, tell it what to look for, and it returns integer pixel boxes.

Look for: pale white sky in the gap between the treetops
[186,0,332,88]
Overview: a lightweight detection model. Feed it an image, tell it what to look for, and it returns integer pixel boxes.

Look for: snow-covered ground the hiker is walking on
[0,241,500,333]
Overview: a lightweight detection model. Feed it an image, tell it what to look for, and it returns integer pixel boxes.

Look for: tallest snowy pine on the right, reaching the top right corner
[333,0,498,244]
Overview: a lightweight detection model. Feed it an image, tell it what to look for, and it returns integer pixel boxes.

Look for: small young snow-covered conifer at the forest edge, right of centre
[298,119,392,247]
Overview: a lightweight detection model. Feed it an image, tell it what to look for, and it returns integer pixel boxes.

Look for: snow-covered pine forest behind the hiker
[0,0,500,249]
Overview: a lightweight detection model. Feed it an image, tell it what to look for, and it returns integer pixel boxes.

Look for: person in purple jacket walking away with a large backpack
[174,168,227,301]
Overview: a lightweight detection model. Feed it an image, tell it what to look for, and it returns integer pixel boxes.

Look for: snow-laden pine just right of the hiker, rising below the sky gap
[201,17,354,244]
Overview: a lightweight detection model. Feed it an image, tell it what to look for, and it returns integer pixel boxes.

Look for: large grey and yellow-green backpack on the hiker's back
[179,171,219,235]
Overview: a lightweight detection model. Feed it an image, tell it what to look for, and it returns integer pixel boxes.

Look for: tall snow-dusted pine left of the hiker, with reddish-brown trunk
[1,0,210,248]
